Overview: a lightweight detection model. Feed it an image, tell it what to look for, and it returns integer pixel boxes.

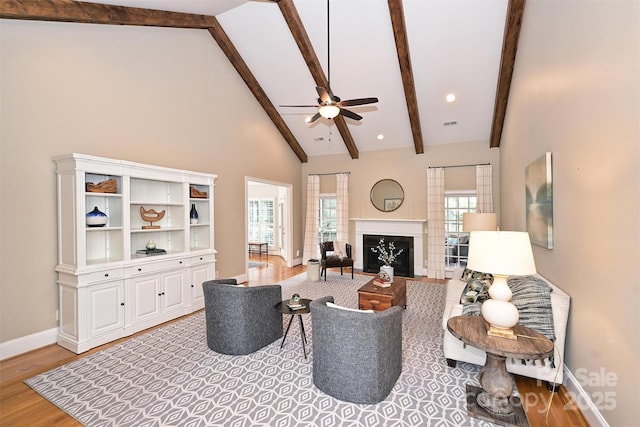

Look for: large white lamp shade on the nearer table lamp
[467,231,536,276]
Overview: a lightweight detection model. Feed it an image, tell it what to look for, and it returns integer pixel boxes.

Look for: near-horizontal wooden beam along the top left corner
[0,0,220,29]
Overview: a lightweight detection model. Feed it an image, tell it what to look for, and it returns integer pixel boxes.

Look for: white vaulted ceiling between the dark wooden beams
[84,0,507,156]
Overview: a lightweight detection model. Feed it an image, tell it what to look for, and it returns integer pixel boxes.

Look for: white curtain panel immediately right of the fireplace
[427,168,445,279]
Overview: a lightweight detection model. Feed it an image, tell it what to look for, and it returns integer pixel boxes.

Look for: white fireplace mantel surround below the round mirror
[351,218,427,276]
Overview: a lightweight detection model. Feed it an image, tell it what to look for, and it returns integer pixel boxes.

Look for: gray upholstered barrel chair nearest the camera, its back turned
[309,296,402,404]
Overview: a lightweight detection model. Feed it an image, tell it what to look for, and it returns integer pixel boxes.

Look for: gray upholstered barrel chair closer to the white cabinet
[202,279,282,355]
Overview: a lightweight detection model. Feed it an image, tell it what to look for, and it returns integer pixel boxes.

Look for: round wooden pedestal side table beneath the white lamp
[447,316,553,427]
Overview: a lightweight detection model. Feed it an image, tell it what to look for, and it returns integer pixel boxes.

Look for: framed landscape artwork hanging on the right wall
[525,152,553,249]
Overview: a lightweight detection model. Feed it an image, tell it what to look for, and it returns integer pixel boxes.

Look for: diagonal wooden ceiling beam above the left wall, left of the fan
[208,18,308,163]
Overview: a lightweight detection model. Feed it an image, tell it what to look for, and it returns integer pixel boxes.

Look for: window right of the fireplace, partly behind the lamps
[444,192,477,268]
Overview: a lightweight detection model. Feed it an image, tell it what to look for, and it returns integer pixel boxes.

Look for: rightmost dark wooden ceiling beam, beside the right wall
[489,0,526,148]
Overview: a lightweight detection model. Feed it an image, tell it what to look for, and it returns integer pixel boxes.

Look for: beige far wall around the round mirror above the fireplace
[302,141,500,259]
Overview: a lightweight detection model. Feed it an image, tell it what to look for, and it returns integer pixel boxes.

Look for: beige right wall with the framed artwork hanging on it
[500,0,640,426]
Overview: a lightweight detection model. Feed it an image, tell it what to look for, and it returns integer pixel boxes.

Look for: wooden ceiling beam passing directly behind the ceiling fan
[278,0,359,159]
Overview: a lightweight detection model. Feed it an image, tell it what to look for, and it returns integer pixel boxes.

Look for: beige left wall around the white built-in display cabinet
[0,20,302,342]
